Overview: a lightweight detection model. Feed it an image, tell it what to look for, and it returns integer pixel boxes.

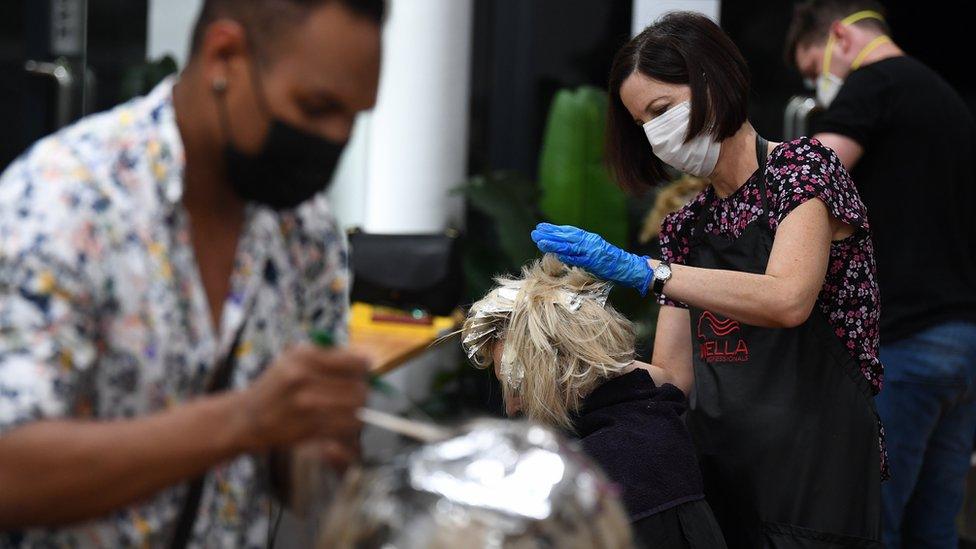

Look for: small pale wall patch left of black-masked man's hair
[146,0,203,68]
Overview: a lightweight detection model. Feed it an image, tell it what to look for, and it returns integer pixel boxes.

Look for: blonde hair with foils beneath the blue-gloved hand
[461,255,635,430]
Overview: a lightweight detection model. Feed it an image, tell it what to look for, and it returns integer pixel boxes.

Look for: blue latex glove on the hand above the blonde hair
[532,223,654,295]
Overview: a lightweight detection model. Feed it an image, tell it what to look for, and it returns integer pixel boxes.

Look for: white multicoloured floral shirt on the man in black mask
[0,79,348,547]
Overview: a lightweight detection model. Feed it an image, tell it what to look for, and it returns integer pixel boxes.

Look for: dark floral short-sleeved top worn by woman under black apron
[660,138,883,394]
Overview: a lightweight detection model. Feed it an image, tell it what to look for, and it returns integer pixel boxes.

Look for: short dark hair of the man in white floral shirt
[190,0,386,61]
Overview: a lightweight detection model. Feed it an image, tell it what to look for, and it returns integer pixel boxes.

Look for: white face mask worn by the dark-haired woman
[644,101,722,177]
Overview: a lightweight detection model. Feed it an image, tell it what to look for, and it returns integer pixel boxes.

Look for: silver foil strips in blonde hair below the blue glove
[461,279,613,387]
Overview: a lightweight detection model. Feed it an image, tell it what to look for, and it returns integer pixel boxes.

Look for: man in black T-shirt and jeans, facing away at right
[786,0,976,548]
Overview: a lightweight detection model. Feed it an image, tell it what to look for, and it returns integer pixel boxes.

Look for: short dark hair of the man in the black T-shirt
[783,0,891,67]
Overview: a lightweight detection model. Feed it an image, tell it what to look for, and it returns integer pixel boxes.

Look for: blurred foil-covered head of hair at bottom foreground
[318,420,633,549]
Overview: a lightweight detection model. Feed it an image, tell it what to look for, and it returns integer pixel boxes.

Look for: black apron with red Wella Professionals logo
[687,138,881,549]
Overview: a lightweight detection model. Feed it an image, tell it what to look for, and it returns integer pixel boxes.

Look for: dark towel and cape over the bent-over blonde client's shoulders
[572,368,725,549]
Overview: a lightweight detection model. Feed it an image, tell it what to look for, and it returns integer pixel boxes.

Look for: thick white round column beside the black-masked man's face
[364,0,473,233]
